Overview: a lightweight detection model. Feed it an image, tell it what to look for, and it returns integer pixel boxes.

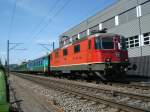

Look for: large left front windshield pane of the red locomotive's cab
[102,37,114,49]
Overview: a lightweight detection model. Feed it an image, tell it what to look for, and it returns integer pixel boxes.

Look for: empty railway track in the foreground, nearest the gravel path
[12,74,150,112]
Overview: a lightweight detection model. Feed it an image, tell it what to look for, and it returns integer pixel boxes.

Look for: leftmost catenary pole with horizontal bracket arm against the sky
[7,40,26,77]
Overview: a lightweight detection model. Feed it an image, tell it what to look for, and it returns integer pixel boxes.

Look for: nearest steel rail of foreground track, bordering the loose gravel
[12,75,150,112]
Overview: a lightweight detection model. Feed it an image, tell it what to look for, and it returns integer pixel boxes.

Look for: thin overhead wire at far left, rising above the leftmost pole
[8,0,18,40]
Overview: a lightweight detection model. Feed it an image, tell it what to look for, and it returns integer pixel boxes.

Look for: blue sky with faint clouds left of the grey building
[0,0,116,63]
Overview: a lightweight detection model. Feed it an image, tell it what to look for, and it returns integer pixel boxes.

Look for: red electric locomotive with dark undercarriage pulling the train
[49,29,135,80]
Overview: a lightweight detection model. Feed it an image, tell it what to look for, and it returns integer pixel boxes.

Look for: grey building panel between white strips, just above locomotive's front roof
[103,17,115,29]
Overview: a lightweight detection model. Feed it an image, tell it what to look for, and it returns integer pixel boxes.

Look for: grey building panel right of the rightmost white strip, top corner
[141,0,150,15]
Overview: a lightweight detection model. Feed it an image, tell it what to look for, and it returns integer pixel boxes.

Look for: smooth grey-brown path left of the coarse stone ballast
[9,76,63,112]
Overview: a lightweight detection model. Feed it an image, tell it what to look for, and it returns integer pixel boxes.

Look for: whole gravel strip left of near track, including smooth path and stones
[9,75,118,112]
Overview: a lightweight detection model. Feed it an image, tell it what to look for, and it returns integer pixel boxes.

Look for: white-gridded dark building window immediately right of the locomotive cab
[126,35,140,48]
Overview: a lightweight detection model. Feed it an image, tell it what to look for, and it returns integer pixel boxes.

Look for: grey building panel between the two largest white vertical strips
[119,8,137,24]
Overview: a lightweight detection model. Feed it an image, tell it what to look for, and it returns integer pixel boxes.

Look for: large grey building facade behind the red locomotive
[59,0,150,76]
